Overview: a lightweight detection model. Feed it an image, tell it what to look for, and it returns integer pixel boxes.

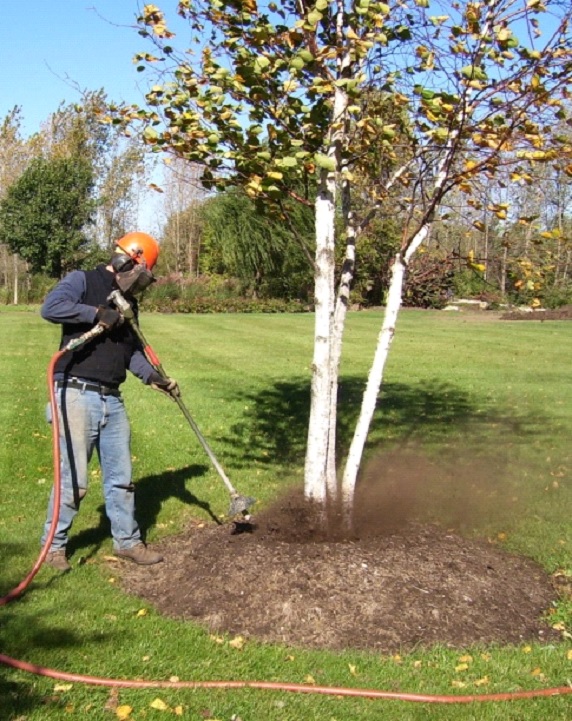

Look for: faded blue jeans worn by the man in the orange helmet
[42,388,141,551]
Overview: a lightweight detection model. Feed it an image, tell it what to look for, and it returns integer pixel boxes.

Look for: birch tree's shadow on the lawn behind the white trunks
[221,377,549,467]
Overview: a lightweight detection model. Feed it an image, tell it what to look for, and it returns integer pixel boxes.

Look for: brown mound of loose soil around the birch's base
[120,464,556,653]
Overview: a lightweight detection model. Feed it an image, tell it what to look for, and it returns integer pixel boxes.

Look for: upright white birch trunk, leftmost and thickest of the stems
[304,181,335,504]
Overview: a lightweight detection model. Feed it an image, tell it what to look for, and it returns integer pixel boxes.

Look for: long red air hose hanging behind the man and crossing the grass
[0,344,572,704]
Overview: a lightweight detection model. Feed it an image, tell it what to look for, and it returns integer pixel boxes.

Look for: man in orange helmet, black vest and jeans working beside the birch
[41,232,179,571]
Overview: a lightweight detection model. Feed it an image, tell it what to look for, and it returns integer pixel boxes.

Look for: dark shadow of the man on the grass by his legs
[68,464,220,561]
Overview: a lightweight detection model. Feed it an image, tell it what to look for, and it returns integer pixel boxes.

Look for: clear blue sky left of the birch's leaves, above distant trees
[0,0,161,136]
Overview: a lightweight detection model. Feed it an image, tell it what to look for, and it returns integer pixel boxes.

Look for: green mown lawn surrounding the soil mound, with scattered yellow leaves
[0,309,572,721]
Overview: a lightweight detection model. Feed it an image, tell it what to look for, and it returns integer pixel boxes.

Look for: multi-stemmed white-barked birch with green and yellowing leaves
[116,0,572,509]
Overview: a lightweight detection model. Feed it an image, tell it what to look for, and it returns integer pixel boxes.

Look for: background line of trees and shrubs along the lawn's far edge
[0,91,572,311]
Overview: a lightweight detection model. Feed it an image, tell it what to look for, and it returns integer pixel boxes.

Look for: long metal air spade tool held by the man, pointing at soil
[108,290,256,521]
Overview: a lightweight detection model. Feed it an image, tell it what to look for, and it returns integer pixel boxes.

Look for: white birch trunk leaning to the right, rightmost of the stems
[342,225,429,521]
